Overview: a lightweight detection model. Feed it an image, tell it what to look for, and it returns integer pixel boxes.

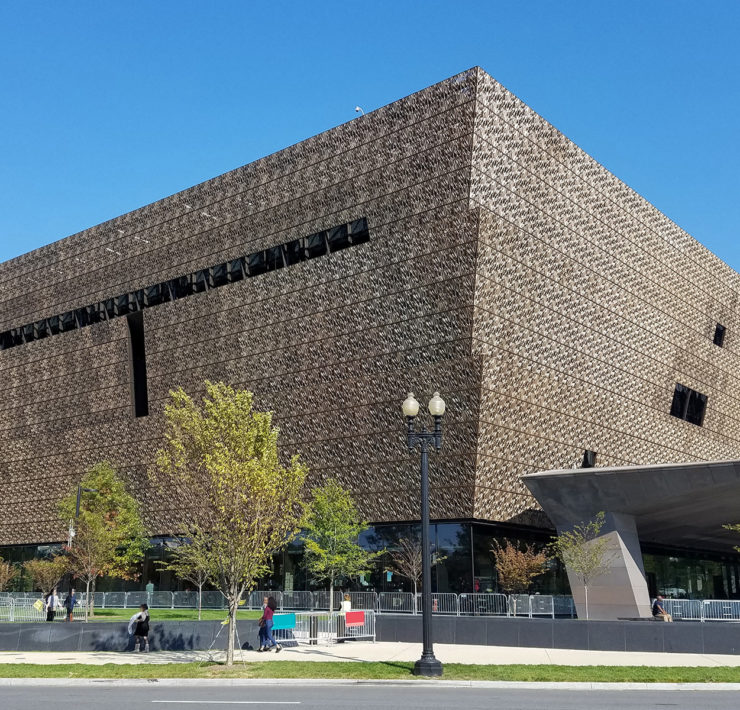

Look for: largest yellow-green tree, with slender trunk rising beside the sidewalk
[157,382,306,665]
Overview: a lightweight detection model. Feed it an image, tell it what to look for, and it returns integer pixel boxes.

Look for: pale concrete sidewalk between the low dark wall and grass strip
[0,642,740,667]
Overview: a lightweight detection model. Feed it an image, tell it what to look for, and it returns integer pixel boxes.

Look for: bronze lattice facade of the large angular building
[0,69,740,545]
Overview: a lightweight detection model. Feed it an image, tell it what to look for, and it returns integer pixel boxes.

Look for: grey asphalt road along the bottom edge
[0,683,738,710]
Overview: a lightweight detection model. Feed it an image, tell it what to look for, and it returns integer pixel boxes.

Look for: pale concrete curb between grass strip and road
[0,678,740,692]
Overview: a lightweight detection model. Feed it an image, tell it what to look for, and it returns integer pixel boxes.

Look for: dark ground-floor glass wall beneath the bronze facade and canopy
[5,522,740,599]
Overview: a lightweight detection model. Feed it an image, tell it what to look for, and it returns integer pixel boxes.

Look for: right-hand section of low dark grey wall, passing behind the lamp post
[375,614,740,654]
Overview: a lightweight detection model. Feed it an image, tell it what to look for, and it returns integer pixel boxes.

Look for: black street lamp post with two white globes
[402,392,445,676]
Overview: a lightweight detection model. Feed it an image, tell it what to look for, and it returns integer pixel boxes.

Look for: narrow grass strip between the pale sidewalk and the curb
[0,661,740,683]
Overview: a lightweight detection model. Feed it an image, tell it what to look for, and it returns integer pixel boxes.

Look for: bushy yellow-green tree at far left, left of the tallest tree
[59,461,149,621]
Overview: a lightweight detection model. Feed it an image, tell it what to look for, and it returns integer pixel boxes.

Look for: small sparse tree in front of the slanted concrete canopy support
[550,512,613,620]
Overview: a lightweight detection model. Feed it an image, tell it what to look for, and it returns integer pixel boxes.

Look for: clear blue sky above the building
[0,0,740,270]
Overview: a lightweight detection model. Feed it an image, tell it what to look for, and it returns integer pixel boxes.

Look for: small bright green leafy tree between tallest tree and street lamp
[305,479,382,611]
